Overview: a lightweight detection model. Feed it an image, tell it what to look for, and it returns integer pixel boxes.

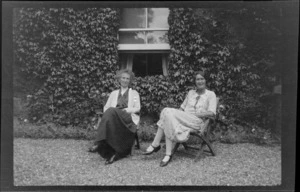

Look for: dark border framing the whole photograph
[1,0,299,191]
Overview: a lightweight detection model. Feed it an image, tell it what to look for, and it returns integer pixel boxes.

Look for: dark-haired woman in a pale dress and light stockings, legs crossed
[143,71,217,167]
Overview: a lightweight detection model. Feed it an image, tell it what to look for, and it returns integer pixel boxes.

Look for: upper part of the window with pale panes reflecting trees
[119,8,170,50]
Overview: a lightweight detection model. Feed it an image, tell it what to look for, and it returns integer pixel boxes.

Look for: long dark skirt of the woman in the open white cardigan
[96,107,136,159]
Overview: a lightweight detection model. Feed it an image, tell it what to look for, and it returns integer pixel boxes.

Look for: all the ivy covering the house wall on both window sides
[14,8,279,136]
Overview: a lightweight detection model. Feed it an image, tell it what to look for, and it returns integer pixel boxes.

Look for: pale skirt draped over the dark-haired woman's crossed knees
[157,108,204,142]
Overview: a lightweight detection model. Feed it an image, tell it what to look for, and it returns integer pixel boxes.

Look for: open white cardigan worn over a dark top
[103,88,141,125]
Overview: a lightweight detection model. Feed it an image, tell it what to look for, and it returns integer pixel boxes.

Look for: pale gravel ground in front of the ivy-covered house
[14,138,281,186]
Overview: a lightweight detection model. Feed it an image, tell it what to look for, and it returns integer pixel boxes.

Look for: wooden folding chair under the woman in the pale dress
[172,98,219,161]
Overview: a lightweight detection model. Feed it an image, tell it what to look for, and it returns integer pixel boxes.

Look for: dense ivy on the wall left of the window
[14,8,119,125]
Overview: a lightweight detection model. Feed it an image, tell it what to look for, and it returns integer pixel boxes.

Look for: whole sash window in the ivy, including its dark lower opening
[118,8,170,77]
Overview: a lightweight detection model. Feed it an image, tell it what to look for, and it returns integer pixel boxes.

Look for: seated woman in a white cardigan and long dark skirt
[89,69,141,165]
